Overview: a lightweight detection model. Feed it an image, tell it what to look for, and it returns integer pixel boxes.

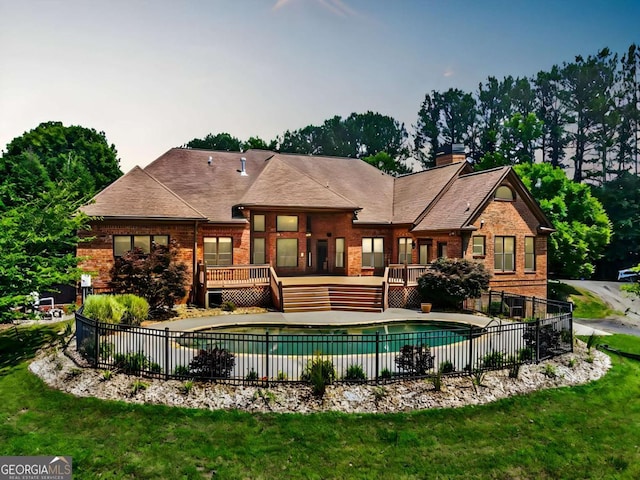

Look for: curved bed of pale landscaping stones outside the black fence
[29,341,611,413]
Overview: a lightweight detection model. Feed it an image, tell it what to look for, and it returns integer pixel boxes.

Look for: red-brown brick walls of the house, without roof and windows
[77,163,547,298]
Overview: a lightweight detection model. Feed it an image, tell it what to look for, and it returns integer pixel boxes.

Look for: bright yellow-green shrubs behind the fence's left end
[82,294,149,325]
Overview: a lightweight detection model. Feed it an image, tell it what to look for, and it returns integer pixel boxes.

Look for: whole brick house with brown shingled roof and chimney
[77,148,553,308]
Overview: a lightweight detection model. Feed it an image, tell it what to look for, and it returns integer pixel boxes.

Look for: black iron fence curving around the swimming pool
[76,294,573,384]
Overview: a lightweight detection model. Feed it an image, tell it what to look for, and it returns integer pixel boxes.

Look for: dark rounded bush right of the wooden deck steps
[418,258,491,309]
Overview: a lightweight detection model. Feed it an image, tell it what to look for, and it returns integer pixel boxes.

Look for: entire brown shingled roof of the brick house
[83,148,548,230]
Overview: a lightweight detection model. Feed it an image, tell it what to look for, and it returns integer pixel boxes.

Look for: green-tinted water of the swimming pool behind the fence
[179,321,470,355]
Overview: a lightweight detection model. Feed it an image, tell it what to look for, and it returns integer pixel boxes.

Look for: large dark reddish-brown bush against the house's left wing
[109,240,187,315]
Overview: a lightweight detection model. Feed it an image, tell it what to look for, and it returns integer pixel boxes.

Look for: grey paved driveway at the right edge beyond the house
[561,280,640,336]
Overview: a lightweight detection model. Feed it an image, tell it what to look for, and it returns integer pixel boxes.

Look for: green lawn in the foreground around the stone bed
[0,320,640,479]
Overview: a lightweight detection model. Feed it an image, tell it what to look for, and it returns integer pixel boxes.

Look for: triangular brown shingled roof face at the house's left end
[81,167,205,220]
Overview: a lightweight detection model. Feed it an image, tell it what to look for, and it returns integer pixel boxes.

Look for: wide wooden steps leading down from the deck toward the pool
[282,284,383,312]
